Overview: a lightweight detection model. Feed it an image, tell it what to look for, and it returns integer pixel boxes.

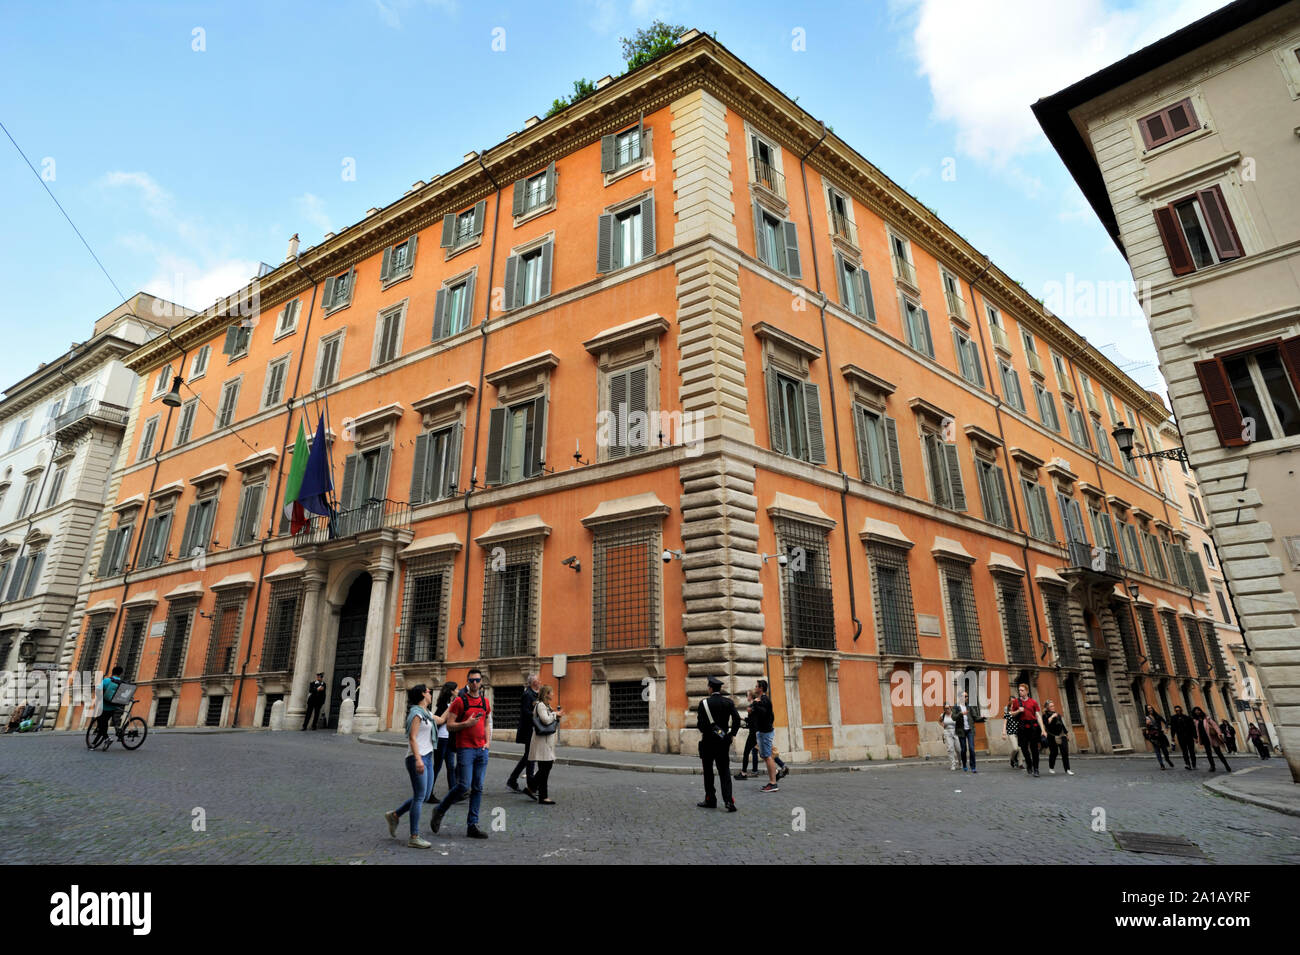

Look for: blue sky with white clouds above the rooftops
[0,0,1221,390]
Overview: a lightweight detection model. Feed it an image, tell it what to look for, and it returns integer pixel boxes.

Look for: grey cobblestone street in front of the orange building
[0,732,1300,864]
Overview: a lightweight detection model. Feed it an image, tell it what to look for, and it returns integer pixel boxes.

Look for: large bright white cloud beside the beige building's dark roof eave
[894,0,1223,166]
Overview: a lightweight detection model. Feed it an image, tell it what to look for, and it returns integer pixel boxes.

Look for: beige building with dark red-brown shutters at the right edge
[1034,0,1300,781]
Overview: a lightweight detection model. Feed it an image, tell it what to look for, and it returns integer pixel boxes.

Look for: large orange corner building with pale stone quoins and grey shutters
[64,32,1227,759]
